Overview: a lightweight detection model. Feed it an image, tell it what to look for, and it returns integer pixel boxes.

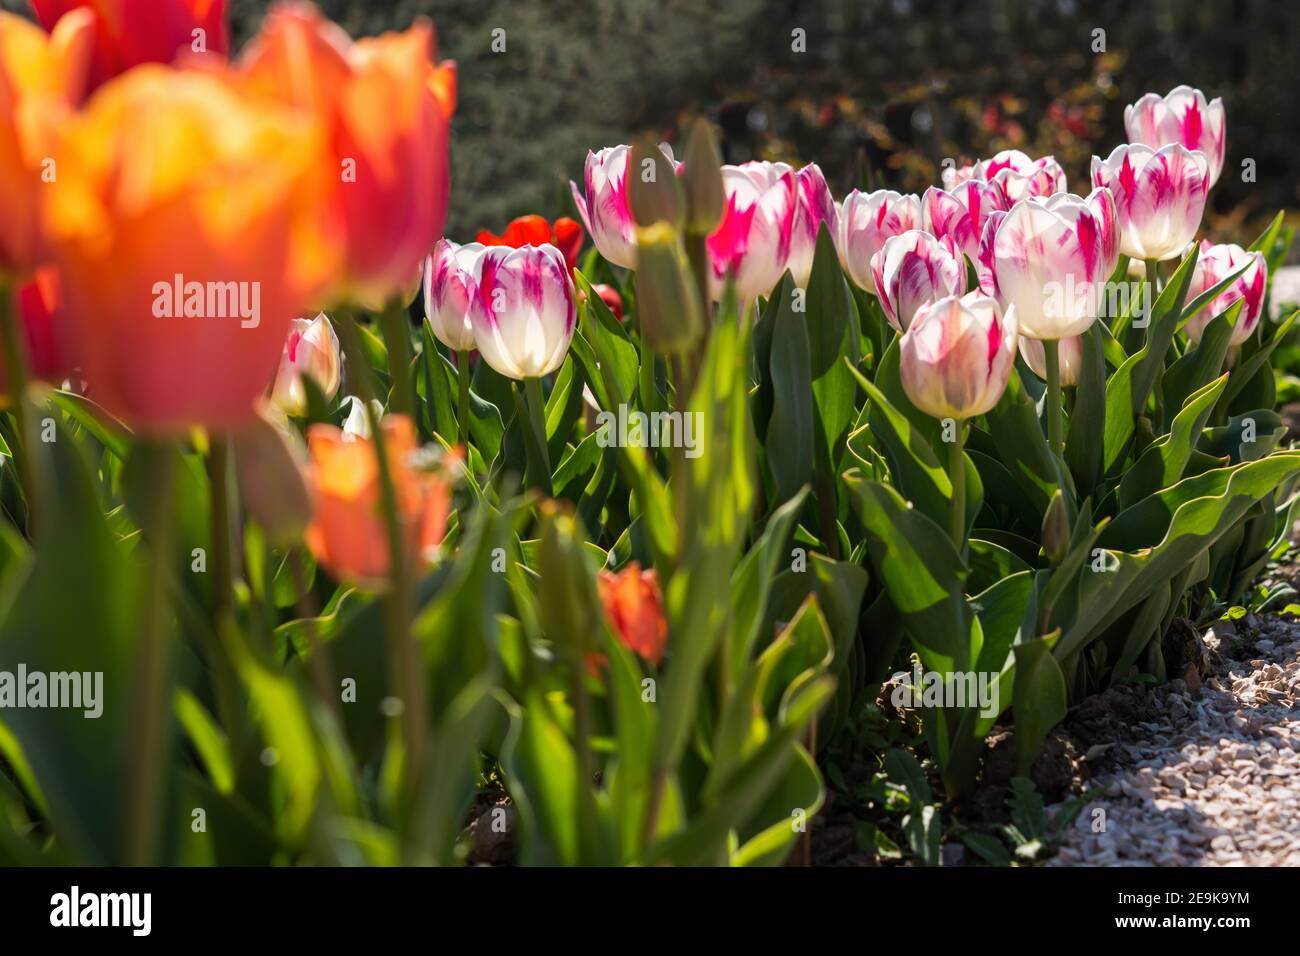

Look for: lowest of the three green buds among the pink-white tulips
[637,222,705,354]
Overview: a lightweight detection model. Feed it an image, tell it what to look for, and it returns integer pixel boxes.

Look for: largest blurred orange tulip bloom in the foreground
[46,65,330,436]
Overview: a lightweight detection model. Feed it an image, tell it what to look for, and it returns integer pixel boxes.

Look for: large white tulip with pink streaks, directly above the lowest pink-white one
[979,189,1119,339]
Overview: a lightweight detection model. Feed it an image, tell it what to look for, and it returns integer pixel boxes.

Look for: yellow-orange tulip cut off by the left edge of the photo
[0,10,95,273]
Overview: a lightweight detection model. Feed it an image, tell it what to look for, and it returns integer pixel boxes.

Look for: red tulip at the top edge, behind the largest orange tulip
[31,0,230,88]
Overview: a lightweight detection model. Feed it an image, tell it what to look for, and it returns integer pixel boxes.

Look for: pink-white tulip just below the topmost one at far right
[1092,143,1210,261]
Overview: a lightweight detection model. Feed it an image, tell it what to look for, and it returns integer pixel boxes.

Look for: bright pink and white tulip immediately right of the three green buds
[705,163,800,303]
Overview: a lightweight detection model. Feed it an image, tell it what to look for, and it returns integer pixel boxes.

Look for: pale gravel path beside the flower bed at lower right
[1049,615,1300,866]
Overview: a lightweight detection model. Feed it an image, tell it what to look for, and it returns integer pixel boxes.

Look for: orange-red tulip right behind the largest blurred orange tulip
[241,3,456,304]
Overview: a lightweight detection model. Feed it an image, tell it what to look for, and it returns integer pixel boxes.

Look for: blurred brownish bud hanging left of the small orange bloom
[231,408,312,548]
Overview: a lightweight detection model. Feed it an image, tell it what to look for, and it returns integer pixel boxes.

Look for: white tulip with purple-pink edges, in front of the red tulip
[469,243,577,381]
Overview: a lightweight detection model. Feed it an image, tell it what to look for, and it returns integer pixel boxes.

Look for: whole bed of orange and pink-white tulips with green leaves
[0,4,1300,865]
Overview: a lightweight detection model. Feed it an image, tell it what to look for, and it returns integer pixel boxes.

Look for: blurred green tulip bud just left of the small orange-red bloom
[538,501,602,661]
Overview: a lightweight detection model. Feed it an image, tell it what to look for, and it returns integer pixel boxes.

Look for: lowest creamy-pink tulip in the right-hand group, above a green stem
[898,293,1017,421]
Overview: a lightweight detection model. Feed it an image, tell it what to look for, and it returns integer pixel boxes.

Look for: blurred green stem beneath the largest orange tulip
[122,445,173,866]
